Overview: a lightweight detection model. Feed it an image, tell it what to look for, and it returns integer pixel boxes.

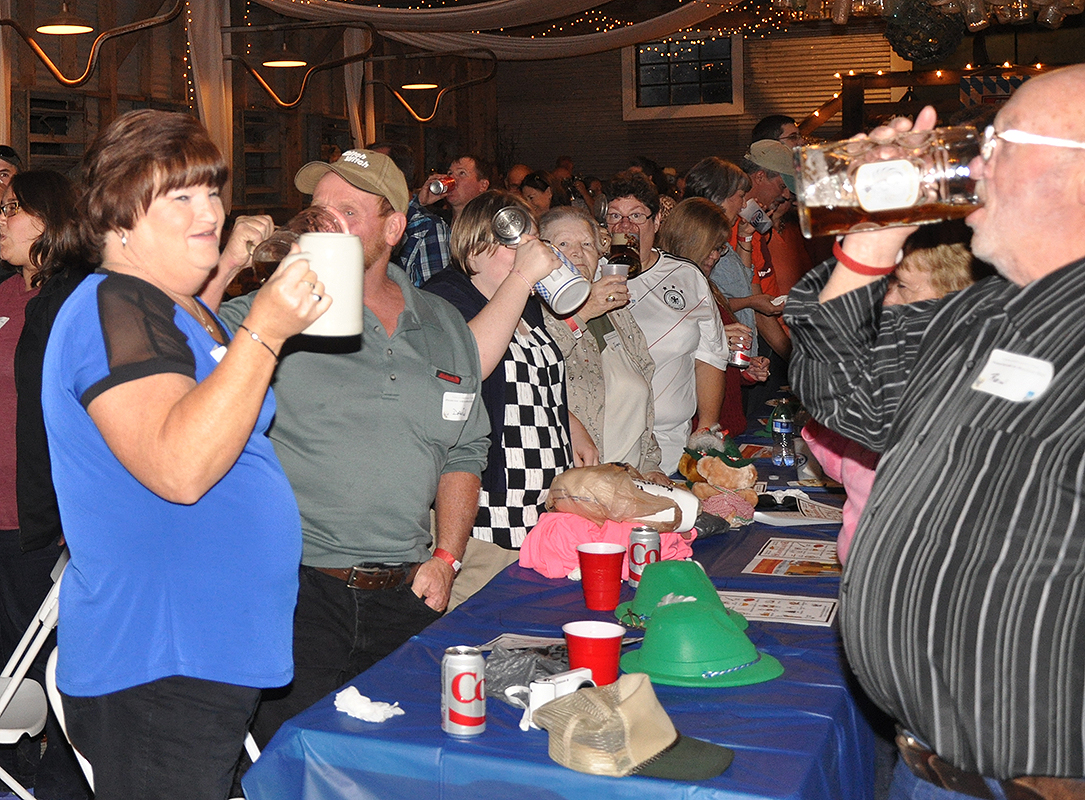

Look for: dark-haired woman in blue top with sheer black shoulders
[42,110,331,800]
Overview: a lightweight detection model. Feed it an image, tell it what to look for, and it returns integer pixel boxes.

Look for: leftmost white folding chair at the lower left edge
[0,550,68,800]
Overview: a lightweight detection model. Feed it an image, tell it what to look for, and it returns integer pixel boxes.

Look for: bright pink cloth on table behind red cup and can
[520,511,697,581]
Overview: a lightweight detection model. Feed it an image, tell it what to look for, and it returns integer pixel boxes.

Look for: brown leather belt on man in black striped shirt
[896,731,1085,800]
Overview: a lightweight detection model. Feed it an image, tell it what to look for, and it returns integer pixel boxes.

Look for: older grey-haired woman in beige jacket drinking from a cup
[539,206,666,480]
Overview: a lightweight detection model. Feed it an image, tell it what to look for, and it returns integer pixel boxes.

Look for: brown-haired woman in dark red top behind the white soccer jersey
[658,198,768,435]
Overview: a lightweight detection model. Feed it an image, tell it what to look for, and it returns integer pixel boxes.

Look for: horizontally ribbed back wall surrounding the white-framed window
[497,26,891,175]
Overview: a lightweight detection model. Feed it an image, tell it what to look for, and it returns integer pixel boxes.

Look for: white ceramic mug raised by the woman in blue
[283,232,365,336]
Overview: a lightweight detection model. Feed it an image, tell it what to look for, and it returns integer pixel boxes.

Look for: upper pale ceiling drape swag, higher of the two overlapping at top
[249,0,599,33]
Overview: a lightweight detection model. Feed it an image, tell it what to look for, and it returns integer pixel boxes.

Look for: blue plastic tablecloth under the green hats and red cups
[244,499,873,800]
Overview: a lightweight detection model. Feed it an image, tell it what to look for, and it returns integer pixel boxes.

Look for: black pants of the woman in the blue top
[63,675,260,800]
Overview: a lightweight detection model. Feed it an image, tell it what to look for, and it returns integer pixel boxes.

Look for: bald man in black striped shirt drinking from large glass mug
[784,64,1085,800]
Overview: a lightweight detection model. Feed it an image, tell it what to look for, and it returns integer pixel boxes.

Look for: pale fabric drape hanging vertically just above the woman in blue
[186,0,233,211]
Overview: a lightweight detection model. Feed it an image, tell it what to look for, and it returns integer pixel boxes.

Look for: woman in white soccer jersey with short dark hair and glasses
[607,174,727,474]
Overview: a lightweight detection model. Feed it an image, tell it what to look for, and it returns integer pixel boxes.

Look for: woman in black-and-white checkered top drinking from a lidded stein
[425,192,585,602]
